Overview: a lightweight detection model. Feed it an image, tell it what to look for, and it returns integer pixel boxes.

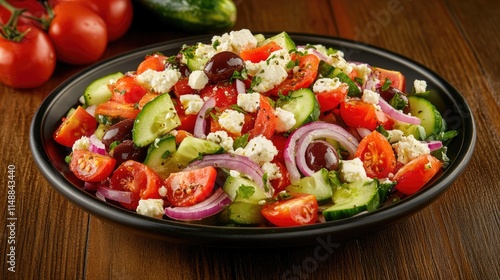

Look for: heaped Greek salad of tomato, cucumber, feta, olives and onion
[53,29,457,227]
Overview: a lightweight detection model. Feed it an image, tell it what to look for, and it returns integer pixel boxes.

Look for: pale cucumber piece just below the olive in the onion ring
[286,168,333,204]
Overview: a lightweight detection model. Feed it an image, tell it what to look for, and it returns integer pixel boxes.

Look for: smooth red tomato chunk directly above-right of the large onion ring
[340,100,393,130]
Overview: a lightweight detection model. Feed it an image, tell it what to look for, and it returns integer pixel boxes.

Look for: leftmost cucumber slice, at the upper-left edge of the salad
[83,72,123,107]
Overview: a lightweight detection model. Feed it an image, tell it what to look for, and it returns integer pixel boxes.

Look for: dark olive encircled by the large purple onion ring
[306,140,339,171]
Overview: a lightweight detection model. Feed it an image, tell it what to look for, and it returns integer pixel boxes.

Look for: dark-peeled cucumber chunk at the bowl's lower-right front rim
[323,180,380,221]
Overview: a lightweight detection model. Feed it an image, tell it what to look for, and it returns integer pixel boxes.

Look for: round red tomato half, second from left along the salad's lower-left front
[109,160,161,209]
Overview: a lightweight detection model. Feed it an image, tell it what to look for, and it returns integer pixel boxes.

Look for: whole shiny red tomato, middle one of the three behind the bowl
[48,2,108,65]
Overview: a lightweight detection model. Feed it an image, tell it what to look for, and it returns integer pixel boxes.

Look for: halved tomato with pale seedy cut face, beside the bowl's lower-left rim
[69,150,116,183]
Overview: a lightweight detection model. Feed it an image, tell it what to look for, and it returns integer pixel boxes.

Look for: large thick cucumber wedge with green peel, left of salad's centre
[132,93,181,147]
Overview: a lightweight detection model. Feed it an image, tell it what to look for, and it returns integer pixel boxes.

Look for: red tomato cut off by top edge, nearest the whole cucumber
[49,0,133,41]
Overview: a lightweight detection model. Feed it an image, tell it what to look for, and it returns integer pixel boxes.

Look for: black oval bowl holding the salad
[30,34,476,247]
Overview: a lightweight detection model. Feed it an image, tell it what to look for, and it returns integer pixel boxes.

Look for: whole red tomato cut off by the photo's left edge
[0,25,56,88]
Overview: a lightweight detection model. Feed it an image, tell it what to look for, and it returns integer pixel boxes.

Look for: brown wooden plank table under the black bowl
[0,0,500,279]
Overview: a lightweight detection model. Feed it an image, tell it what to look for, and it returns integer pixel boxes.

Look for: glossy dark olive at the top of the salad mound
[204,51,245,83]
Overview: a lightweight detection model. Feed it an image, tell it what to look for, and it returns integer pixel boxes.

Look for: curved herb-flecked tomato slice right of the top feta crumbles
[268,54,319,96]
